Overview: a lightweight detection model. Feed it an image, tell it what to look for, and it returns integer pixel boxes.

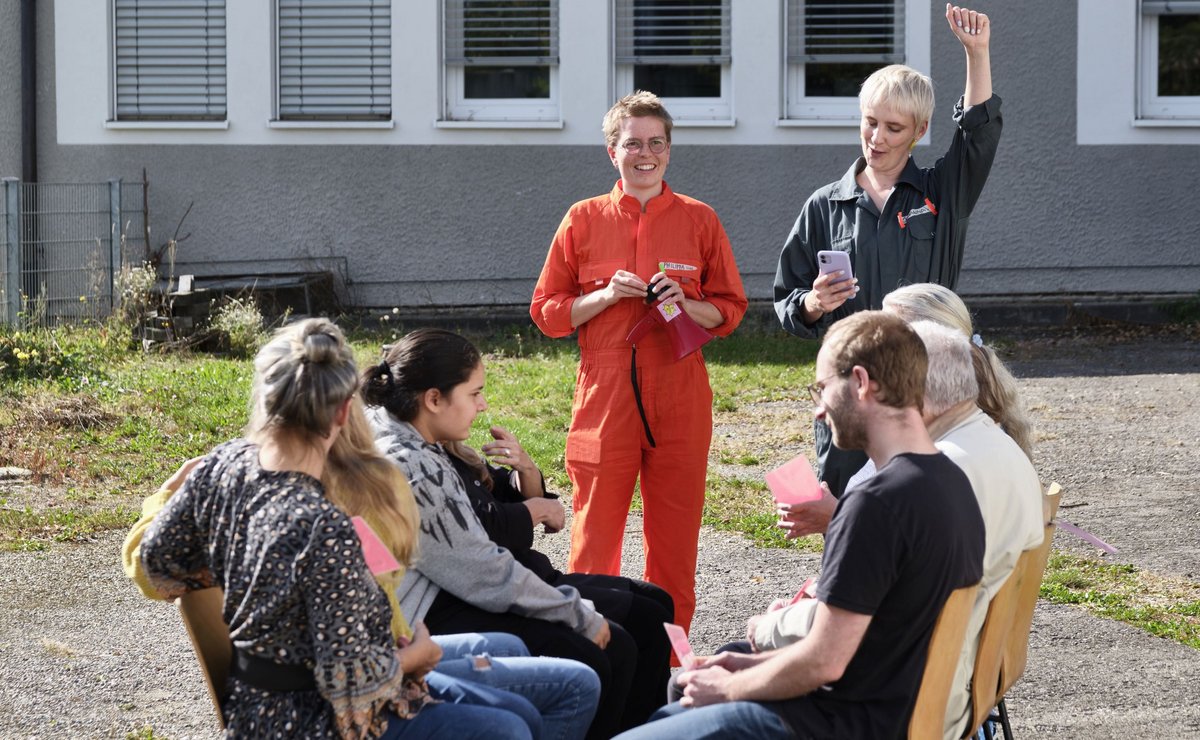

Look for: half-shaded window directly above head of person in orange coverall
[614,0,733,122]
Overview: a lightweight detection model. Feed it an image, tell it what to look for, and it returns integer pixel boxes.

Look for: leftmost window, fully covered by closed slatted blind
[108,0,229,126]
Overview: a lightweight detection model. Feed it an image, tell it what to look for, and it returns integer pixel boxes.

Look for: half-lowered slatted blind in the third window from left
[445,0,558,66]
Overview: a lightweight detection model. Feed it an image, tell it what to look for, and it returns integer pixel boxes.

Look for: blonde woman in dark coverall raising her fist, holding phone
[774,4,1002,497]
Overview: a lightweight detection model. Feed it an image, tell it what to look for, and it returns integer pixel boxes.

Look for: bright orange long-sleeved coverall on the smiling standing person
[529,181,746,628]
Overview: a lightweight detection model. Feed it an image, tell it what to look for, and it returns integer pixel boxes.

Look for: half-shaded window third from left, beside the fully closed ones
[443,0,560,121]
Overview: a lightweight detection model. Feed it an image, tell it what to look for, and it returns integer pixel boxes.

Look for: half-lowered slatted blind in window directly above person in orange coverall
[616,0,732,65]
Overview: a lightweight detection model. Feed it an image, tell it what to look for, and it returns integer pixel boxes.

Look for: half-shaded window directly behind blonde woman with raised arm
[785,0,905,121]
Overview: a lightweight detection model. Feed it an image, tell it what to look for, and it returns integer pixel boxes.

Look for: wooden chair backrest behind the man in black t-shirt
[908,584,979,740]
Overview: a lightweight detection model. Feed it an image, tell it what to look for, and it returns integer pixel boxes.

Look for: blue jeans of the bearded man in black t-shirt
[617,702,796,740]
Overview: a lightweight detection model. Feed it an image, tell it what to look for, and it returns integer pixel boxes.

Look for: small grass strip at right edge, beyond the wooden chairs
[1042,552,1200,649]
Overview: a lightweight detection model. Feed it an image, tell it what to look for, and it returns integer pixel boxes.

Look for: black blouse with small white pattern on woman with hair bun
[142,440,425,738]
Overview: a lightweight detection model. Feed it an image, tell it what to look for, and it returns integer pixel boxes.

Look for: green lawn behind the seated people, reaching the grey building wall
[0,326,816,548]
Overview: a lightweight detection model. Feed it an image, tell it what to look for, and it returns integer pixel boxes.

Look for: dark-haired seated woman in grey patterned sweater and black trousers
[362,329,637,738]
